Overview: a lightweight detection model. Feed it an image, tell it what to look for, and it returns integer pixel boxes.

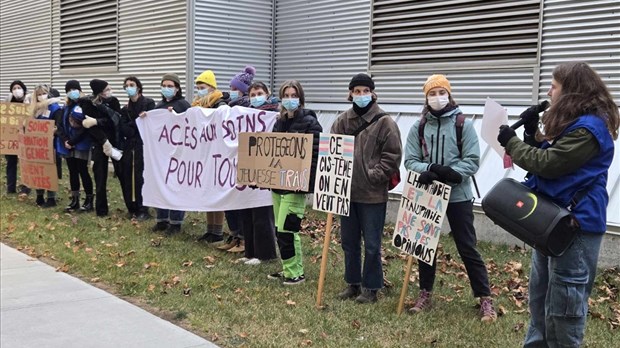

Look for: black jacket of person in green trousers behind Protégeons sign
[273,109,323,194]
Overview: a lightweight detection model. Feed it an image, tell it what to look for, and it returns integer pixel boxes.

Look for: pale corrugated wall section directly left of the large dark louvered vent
[274,0,371,102]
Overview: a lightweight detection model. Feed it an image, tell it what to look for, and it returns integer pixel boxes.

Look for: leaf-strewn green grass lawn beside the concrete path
[0,159,620,347]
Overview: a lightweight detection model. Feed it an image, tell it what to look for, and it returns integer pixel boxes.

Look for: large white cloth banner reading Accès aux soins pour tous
[136,105,277,211]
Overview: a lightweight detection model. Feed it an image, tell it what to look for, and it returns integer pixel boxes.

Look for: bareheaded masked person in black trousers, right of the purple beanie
[231,80,279,265]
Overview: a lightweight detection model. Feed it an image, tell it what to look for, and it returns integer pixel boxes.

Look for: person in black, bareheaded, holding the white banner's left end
[119,76,155,221]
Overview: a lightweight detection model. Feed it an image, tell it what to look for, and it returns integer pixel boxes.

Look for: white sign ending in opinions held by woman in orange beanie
[392,171,451,265]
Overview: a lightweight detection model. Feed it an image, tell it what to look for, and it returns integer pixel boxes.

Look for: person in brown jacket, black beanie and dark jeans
[331,74,402,303]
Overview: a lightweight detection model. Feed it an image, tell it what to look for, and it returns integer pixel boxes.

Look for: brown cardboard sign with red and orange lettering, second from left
[19,119,58,191]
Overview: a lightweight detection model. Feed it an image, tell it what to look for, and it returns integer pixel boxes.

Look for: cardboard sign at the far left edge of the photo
[0,103,32,155]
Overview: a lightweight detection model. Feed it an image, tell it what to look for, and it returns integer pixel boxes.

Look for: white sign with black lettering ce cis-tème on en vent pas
[312,133,355,216]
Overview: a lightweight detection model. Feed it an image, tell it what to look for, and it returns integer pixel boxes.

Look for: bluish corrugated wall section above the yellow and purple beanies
[193,0,273,95]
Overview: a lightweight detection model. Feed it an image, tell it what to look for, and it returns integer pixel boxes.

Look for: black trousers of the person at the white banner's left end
[118,145,148,214]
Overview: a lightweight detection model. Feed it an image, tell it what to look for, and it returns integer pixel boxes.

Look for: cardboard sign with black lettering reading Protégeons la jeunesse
[237,133,312,191]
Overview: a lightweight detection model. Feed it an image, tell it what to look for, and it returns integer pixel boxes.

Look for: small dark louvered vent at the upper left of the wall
[59,0,119,69]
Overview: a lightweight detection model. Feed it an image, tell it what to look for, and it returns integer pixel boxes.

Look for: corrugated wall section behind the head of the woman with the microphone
[539,0,620,105]
